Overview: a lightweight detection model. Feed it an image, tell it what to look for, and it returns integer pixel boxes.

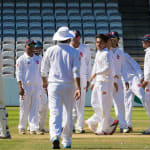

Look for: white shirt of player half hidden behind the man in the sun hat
[72,44,91,81]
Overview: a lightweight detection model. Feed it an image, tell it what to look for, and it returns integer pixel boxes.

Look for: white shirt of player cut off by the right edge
[144,47,150,82]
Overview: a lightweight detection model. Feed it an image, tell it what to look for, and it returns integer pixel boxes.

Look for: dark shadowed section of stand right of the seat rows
[118,0,150,67]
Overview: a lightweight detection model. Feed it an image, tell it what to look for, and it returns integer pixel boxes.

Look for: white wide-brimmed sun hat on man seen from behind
[53,27,75,41]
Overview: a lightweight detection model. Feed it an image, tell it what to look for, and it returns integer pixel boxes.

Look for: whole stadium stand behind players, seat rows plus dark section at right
[0,0,149,77]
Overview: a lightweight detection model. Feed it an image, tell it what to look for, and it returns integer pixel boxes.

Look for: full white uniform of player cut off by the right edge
[144,47,150,127]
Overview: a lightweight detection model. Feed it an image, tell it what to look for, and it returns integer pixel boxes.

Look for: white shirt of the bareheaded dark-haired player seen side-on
[92,48,113,82]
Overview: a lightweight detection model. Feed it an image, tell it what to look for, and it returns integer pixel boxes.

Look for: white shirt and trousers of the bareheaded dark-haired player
[91,49,113,132]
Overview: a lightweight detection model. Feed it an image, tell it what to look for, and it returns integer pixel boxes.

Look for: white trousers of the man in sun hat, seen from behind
[48,83,74,145]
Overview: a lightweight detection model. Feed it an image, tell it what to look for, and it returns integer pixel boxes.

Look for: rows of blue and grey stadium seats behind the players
[0,0,123,77]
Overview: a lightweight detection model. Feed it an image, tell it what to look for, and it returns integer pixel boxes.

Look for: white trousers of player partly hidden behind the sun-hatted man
[72,78,87,130]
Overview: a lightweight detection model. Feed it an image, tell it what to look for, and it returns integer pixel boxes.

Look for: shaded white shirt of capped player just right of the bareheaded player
[111,47,128,82]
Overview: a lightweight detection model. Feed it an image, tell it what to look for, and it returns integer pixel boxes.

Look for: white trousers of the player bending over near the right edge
[124,76,145,127]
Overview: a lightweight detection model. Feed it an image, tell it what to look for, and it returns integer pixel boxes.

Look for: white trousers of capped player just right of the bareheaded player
[113,79,127,128]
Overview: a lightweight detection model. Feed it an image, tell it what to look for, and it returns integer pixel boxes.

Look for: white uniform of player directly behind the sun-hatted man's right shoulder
[73,44,91,130]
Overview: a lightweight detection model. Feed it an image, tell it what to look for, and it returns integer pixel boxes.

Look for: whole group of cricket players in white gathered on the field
[0,27,150,149]
